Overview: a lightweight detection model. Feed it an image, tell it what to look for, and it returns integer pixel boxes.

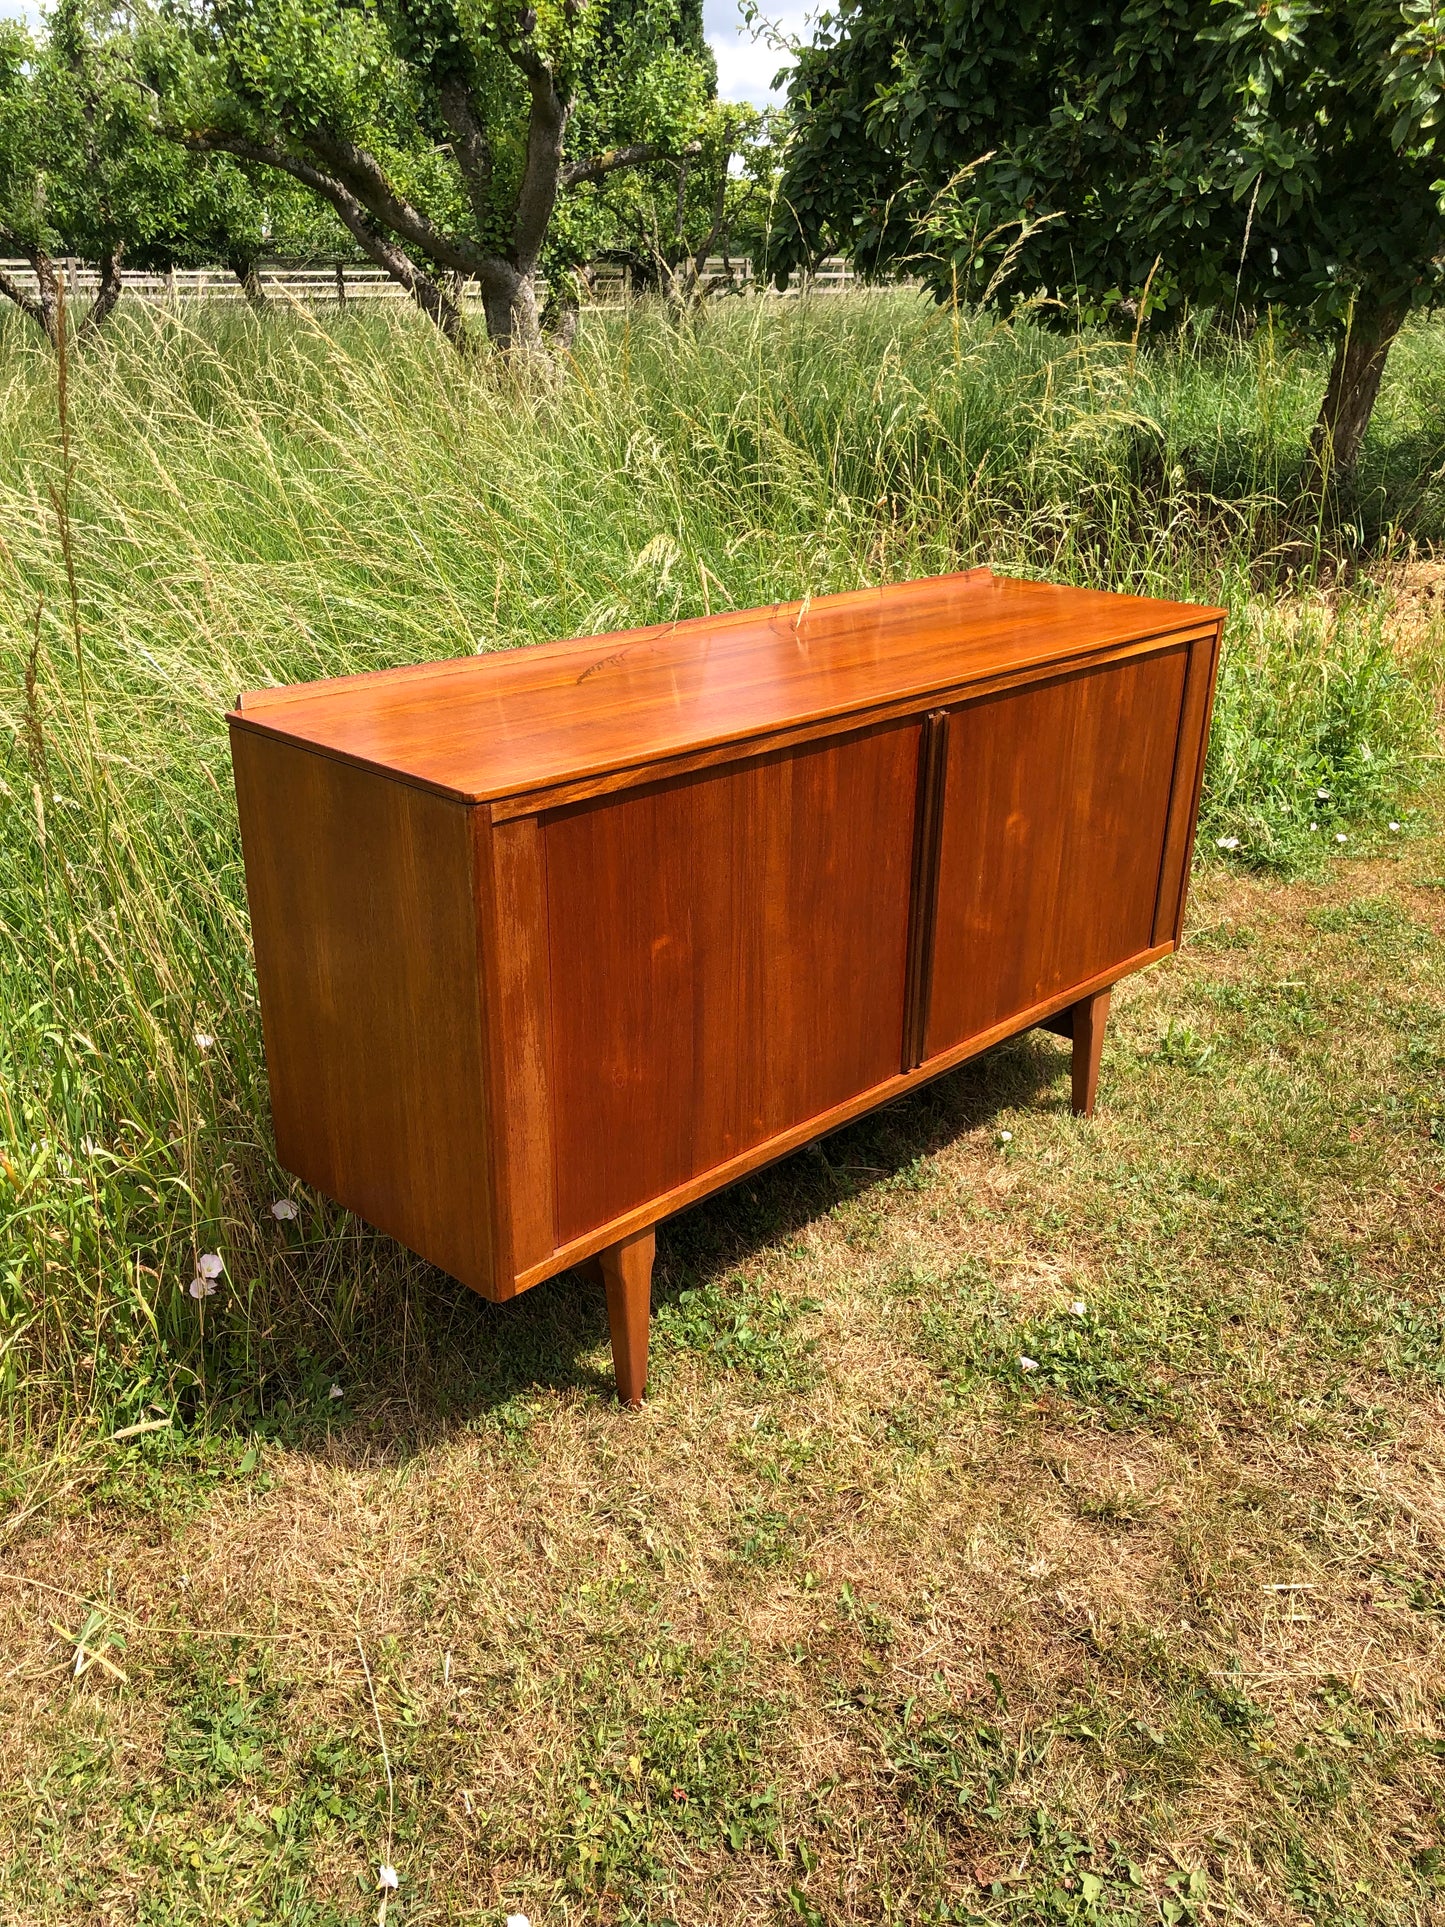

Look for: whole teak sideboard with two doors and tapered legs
[229,568,1223,1405]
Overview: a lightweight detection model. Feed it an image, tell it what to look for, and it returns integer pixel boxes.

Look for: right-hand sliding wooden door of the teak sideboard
[925,646,1187,1058]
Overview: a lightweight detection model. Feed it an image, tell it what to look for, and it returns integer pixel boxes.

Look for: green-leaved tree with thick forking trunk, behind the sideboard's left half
[146,0,711,347]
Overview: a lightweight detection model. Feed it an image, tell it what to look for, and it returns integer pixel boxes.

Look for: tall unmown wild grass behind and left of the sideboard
[0,295,1445,1453]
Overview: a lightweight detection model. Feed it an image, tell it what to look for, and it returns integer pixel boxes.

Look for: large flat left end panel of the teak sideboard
[231,730,493,1295]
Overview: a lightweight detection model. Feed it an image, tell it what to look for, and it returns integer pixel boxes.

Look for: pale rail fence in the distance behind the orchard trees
[0,256,855,306]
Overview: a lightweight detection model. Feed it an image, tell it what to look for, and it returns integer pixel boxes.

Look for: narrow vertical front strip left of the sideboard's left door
[476,809,557,1297]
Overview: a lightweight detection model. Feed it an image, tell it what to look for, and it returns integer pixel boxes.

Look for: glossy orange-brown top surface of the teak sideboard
[231,568,1223,804]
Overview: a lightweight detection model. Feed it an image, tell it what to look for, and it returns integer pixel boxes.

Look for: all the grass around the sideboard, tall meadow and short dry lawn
[0,297,1445,1927]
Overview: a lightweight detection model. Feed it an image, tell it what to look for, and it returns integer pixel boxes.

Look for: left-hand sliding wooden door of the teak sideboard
[541,721,919,1243]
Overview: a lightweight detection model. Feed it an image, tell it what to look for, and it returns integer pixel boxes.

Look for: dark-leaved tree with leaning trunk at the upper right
[775,0,1445,486]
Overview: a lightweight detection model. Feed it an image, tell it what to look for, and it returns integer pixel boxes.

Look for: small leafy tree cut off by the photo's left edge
[0,0,137,343]
